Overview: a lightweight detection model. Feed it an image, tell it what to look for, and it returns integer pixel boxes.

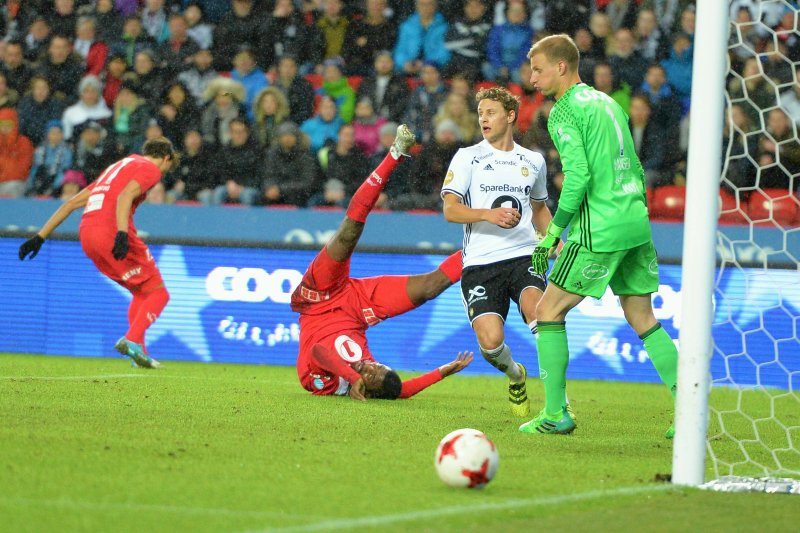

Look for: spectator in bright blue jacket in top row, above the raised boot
[394,0,450,76]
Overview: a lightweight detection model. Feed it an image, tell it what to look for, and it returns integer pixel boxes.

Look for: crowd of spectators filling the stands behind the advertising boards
[0,0,800,216]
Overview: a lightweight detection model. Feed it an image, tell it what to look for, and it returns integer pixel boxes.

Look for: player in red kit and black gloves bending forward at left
[19,137,177,368]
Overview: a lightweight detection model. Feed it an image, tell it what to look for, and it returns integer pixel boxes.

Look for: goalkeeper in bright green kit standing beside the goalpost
[519,34,678,438]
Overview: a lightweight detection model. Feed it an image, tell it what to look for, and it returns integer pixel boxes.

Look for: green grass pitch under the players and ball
[0,354,800,533]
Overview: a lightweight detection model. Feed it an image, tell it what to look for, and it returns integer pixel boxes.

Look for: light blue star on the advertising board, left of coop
[105,246,212,361]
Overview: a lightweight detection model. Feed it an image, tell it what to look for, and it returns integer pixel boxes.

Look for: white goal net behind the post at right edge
[708,0,800,493]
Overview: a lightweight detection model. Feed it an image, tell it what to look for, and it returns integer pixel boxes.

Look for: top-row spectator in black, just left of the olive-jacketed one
[261,0,325,72]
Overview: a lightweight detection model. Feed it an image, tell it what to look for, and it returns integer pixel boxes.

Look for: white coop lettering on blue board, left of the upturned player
[206,266,303,304]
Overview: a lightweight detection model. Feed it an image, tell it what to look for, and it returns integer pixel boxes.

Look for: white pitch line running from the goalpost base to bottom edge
[255,485,675,533]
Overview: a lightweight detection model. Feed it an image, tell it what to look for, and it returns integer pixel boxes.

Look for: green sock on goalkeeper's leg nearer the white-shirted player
[536,322,569,420]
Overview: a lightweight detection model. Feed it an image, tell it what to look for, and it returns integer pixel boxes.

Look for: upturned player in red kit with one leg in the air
[292,125,472,400]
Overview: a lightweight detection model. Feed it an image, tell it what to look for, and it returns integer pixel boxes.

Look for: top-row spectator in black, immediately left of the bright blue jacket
[342,0,397,76]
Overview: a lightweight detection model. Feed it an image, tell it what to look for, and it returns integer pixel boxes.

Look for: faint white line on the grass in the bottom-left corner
[0,496,306,520]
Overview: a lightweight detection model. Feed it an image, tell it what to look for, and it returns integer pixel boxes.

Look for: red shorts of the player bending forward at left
[80,226,161,291]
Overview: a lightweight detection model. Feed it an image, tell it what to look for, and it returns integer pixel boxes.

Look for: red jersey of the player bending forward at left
[81,154,161,236]
